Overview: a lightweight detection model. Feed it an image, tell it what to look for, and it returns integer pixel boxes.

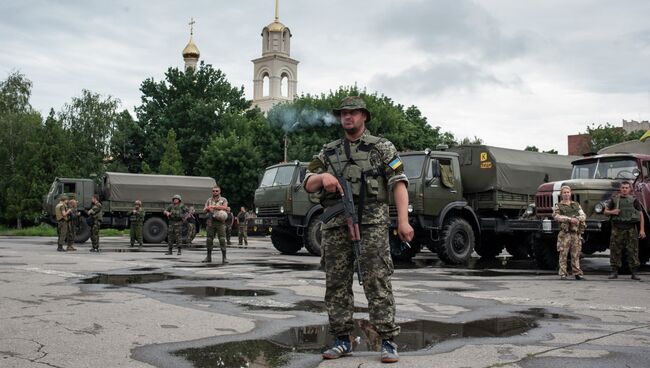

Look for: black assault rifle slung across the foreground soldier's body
[321,150,365,285]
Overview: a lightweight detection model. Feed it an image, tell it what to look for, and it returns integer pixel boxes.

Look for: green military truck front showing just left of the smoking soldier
[254,161,323,256]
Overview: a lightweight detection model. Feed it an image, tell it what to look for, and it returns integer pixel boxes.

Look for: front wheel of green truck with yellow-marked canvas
[438,218,474,264]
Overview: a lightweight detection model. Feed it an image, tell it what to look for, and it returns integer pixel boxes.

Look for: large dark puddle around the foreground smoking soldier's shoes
[172,311,539,367]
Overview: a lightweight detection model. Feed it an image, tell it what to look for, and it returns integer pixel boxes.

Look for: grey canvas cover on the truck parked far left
[104,172,216,203]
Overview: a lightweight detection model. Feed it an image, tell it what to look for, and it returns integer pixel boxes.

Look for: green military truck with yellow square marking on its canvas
[390,145,573,264]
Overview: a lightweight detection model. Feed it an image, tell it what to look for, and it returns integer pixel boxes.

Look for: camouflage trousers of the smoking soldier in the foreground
[321,225,400,339]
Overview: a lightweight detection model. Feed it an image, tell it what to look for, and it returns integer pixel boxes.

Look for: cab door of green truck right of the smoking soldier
[423,157,460,216]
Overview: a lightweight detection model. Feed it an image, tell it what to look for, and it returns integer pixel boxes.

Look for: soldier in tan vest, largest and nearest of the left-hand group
[202,185,230,263]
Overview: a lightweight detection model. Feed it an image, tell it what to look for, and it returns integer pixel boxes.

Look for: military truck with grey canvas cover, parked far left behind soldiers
[43,172,216,243]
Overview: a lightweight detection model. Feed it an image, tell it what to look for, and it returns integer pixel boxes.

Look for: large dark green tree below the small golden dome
[136,62,250,175]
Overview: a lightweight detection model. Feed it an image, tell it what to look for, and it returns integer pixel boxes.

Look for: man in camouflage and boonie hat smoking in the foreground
[304,96,413,363]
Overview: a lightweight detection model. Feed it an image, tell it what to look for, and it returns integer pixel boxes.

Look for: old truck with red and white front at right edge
[535,151,650,269]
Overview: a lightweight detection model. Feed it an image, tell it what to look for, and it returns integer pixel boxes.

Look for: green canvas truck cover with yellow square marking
[450,145,579,195]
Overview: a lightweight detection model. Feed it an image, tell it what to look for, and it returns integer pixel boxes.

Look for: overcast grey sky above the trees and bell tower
[0,0,650,153]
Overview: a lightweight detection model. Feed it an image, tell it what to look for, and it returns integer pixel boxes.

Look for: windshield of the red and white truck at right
[571,158,638,179]
